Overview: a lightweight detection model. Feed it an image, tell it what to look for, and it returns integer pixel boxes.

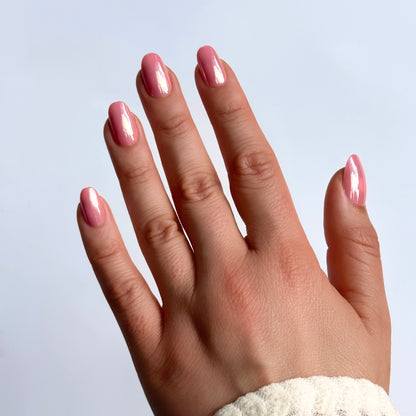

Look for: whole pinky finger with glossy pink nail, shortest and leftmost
[77,188,162,362]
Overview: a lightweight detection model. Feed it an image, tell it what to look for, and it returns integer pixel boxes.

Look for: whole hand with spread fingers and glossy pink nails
[78,47,390,416]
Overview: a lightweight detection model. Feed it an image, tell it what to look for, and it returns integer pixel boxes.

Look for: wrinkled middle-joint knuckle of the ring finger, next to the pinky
[143,215,180,247]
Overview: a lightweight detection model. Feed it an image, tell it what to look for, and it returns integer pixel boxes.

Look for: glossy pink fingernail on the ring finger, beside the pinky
[108,101,138,146]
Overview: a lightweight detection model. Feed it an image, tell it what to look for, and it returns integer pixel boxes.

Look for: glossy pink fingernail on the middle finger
[141,53,172,97]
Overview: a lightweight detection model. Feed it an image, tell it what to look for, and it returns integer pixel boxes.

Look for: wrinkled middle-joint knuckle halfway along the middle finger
[174,173,221,202]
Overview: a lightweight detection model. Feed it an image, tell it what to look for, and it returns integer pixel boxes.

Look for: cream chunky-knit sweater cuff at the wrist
[214,376,399,416]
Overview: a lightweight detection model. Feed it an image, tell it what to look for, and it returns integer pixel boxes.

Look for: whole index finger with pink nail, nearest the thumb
[195,46,303,250]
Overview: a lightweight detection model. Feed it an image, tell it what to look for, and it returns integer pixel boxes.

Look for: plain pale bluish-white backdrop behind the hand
[0,0,416,416]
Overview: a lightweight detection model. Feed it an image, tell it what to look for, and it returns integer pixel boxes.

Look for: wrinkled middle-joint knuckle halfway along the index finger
[229,147,276,183]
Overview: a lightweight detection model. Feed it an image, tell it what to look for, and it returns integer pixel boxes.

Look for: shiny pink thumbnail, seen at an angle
[342,155,367,206]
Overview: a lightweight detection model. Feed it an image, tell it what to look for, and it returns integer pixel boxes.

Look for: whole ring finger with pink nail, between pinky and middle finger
[104,102,194,304]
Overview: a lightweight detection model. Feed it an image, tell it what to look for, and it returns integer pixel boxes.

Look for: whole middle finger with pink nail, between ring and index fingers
[137,54,246,260]
